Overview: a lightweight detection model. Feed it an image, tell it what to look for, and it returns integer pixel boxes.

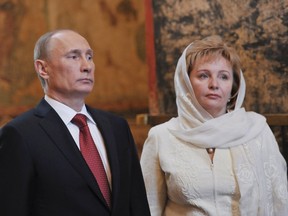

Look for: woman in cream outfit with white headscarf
[141,36,288,216]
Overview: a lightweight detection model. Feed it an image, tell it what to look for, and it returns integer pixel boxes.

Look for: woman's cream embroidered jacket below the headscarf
[141,114,288,216]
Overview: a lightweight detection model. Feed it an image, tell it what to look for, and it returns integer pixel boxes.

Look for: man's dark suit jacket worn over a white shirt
[0,100,150,216]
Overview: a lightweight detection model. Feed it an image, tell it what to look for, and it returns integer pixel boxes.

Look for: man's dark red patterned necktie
[71,114,111,207]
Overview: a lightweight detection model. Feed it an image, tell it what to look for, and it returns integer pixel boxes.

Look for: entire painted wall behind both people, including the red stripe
[0,0,288,156]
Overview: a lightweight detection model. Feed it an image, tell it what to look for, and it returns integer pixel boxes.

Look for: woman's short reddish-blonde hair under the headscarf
[186,35,241,109]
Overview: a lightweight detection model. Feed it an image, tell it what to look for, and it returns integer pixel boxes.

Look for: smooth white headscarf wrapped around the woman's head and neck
[171,43,265,148]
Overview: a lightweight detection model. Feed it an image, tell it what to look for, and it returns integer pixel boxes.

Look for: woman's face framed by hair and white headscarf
[190,56,233,117]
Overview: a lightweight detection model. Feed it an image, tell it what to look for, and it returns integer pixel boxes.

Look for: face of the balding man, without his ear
[46,31,95,101]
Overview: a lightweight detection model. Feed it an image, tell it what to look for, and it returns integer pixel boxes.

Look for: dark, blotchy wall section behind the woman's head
[146,0,288,114]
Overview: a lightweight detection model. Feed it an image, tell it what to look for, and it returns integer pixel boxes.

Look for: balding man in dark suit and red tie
[0,30,150,216]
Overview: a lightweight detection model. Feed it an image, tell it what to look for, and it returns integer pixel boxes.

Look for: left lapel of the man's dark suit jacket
[35,100,108,208]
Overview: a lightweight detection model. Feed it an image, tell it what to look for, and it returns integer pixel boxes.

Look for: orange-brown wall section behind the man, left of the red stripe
[0,0,148,121]
